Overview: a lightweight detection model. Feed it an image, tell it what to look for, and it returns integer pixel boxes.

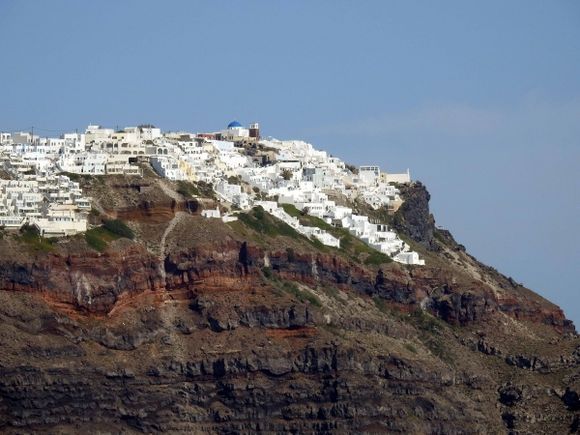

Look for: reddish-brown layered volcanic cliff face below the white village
[0,175,580,434]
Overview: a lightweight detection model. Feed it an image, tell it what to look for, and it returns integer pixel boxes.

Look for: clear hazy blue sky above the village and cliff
[0,0,580,325]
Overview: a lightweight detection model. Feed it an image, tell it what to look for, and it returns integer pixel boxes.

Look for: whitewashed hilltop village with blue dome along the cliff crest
[0,121,425,265]
